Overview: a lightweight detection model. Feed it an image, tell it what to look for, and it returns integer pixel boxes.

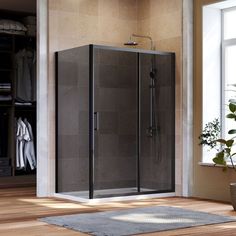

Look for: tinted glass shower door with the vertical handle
[93,48,138,197]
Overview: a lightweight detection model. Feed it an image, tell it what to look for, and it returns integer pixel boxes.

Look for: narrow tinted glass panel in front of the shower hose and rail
[139,53,175,192]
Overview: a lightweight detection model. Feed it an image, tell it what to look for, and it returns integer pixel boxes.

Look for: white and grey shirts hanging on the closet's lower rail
[16,118,36,170]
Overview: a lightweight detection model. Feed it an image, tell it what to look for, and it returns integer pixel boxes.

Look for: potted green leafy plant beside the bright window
[199,99,236,210]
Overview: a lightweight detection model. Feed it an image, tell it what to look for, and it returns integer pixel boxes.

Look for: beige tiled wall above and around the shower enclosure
[48,0,182,195]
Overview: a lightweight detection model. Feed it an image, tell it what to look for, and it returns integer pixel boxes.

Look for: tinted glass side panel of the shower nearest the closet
[57,47,89,197]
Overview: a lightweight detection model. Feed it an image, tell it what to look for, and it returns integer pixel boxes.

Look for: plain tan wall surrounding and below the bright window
[193,0,236,201]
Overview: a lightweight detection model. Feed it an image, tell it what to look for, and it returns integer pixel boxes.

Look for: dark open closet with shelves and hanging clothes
[0,1,37,188]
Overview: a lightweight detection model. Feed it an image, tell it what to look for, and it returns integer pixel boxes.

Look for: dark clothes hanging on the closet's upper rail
[15,49,36,102]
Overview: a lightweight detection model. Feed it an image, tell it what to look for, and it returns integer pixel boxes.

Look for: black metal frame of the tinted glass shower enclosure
[55,44,175,199]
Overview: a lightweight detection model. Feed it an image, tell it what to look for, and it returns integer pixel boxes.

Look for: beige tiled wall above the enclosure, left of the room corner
[49,0,137,49]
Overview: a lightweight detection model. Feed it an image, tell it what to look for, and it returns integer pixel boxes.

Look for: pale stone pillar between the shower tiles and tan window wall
[182,0,193,197]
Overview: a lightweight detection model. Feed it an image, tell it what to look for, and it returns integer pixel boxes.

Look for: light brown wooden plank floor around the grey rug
[0,188,236,236]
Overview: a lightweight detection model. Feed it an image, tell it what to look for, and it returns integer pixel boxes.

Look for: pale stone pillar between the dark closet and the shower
[37,0,55,197]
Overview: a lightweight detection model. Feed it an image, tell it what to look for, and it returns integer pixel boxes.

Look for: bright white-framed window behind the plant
[202,5,236,163]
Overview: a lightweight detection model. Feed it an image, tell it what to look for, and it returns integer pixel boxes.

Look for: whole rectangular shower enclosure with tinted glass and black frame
[56,45,175,199]
